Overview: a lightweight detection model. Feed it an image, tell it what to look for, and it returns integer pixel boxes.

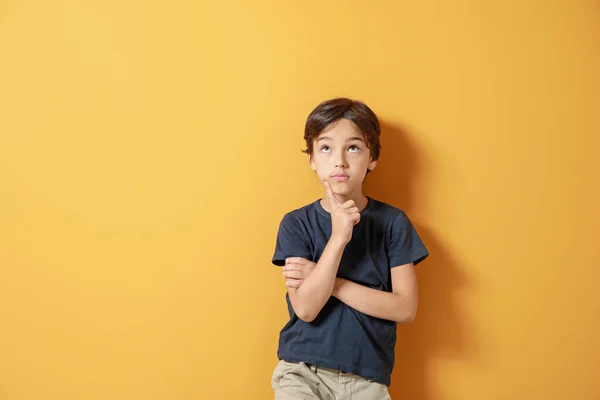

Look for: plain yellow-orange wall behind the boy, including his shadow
[0,0,600,400]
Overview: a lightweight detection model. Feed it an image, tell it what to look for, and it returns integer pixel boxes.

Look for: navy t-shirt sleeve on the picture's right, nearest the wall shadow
[388,211,429,268]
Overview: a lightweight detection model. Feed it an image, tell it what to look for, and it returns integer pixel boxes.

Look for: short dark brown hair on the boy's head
[302,97,381,161]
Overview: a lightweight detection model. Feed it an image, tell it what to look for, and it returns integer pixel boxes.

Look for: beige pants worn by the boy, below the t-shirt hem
[271,360,391,400]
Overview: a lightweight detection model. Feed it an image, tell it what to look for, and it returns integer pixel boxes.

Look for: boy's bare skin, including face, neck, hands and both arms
[283,119,418,323]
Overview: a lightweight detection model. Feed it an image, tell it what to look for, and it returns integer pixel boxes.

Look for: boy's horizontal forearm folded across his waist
[332,278,417,323]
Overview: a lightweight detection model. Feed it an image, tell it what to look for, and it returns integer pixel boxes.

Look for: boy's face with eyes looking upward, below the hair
[310,118,377,196]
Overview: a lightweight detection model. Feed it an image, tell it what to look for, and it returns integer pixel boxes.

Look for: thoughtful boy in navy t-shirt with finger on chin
[271,98,428,400]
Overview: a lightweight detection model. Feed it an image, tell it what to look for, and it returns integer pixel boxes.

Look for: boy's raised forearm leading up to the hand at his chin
[288,239,346,322]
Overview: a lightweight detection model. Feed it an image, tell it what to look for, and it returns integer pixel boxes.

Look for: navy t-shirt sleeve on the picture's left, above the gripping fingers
[272,214,312,267]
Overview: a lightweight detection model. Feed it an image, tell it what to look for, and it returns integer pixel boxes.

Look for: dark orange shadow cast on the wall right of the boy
[365,121,476,400]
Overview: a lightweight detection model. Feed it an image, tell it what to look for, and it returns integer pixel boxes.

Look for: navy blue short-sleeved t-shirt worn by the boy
[272,196,428,386]
